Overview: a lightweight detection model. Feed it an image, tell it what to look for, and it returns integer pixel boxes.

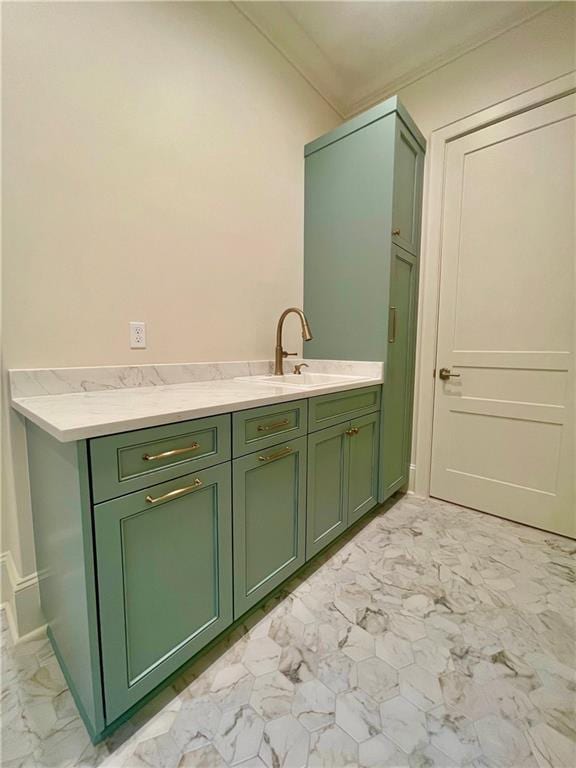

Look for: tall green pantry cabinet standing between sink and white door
[304,97,426,502]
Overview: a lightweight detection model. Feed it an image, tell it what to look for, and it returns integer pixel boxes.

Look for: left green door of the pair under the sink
[306,423,350,560]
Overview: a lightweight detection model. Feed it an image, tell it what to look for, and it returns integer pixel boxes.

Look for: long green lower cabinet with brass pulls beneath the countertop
[26,388,382,742]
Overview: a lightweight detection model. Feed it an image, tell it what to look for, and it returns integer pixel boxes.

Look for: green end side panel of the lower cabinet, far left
[26,421,105,736]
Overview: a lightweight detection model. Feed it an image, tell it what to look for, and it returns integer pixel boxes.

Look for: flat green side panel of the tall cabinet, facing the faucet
[304,114,397,360]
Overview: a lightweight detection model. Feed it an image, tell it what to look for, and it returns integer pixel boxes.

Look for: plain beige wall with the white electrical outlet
[3,3,340,588]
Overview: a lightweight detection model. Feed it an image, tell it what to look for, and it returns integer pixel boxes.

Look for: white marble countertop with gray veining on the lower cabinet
[11,361,383,442]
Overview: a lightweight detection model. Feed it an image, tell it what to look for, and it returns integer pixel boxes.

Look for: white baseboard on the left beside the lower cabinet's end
[0,551,45,643]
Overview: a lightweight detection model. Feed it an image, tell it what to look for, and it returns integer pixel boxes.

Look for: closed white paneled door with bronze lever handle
[431,95,576,536]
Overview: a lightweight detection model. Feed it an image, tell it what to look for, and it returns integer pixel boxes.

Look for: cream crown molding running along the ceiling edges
[233,0,558,119]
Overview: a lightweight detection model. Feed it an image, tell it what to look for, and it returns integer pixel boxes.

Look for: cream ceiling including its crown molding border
[235,0,554,117]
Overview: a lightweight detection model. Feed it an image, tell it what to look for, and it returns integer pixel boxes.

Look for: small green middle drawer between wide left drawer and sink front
[232,400,308,456]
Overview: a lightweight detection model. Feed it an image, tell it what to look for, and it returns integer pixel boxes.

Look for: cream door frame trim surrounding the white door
[409,71,576,498]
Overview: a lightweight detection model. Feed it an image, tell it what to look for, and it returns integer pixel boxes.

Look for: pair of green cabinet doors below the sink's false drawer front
[306,412,380,560]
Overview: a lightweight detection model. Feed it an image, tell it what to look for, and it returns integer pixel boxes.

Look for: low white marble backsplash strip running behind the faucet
[8,358,384,399]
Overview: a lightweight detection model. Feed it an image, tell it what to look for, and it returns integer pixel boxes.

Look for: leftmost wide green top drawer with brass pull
[90,415,230,502]
